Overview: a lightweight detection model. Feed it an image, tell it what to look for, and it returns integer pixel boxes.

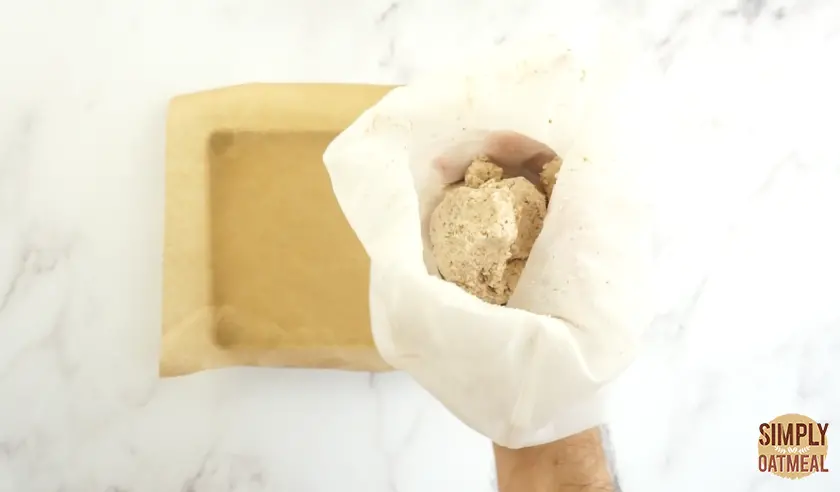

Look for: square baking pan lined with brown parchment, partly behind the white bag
[160,84,398,376]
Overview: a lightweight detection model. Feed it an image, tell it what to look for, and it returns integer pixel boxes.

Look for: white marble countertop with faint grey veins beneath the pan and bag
[0,0,840,492]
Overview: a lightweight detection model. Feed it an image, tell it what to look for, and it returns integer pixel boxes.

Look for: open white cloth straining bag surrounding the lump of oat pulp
[324,30,658,448]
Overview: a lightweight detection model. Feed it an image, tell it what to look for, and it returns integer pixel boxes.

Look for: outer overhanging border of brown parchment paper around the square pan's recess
[164,83,394,377]
